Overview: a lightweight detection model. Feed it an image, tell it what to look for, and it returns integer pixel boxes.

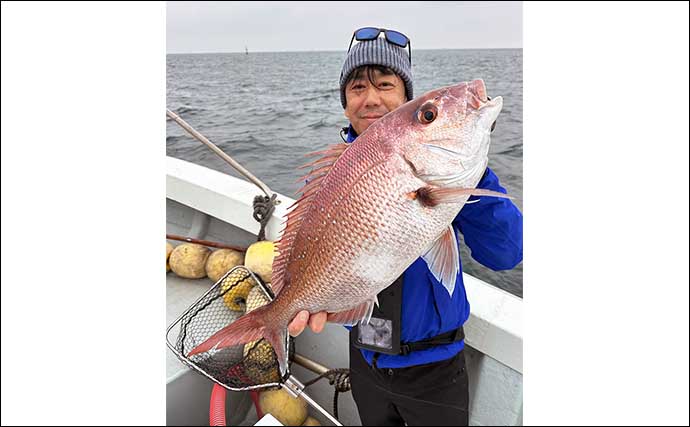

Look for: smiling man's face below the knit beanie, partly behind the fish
[345,69,406,135]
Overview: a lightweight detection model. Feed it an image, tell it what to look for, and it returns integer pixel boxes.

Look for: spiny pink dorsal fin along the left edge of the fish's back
[271,143,351,295]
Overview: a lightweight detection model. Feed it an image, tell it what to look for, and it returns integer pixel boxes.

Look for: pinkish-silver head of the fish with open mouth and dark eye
[380,80,503,187]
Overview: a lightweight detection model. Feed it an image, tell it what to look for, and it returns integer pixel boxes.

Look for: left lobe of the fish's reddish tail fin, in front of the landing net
[188,305,270,357]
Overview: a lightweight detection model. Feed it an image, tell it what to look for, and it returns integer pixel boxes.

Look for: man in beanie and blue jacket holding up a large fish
[289,28,522,425]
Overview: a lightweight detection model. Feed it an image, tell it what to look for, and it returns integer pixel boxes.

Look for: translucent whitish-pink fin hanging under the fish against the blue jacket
[422,225,460,297]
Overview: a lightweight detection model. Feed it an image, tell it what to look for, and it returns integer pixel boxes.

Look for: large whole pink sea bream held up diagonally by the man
[190,80,507,373]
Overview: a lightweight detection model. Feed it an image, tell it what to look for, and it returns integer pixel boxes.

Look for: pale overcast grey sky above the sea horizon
[166,1,522,53]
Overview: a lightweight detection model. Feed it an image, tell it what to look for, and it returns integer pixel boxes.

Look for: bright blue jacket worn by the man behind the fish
[347,126,522,368]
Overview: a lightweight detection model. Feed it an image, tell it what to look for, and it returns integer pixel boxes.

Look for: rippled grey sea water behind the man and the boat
[166,49,522,297]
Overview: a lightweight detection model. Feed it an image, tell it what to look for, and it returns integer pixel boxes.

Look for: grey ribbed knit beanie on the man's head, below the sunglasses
[340,37,412,108]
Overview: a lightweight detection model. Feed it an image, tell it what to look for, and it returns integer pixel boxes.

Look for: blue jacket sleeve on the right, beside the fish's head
[453,167,522,271]
